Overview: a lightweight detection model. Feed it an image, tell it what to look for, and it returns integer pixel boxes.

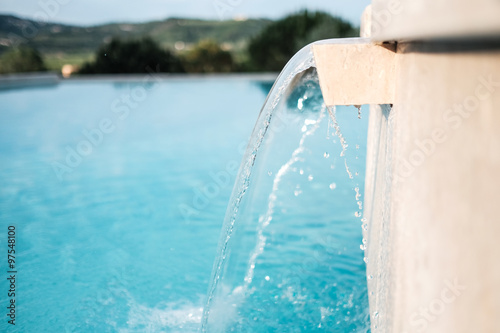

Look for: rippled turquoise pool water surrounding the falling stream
[0,77,367,332]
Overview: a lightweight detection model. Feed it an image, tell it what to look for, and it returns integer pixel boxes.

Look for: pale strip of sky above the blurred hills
[0,0,370,26]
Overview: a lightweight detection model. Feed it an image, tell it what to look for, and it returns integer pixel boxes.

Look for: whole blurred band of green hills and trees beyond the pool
[0,11,359,74]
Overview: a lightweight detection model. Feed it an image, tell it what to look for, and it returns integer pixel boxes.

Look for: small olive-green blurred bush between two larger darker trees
[184,39,236,73]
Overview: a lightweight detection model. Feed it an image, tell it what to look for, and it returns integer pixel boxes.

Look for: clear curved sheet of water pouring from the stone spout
[201,40,369,332]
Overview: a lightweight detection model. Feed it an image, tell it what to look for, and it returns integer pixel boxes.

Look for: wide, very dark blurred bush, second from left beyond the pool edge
[79,37,184,74]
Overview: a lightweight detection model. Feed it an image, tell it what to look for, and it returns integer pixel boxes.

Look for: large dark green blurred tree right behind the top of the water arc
[245,10,359,71]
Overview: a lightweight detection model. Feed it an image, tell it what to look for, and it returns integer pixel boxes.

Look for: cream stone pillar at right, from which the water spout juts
[365,0,500,333]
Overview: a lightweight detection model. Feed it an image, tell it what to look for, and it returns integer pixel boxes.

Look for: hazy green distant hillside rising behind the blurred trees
[0,15,271,69]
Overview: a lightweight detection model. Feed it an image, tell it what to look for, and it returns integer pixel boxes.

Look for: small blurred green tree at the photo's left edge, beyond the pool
[0,46,47,74]
